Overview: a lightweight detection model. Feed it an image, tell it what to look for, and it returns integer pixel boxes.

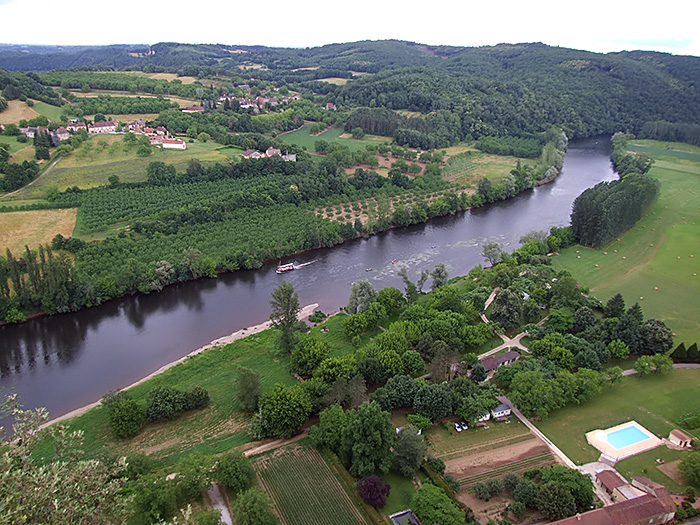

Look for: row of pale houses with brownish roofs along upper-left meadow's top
[19,119,187,150]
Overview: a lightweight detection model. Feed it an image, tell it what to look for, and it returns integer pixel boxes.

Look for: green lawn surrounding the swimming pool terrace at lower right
[537,369,700,464]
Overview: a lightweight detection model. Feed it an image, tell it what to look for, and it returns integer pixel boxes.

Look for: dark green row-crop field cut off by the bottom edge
[255,444,367,525]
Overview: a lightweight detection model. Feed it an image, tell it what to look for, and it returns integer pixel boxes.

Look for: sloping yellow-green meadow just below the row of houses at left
[6,135,230,199]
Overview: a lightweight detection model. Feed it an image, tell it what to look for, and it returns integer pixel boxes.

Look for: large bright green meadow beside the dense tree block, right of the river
[553,141,700,345]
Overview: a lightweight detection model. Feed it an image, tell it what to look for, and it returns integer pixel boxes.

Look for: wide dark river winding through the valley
[0,137,616,424]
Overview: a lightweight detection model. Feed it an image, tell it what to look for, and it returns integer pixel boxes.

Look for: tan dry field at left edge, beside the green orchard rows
[0,209,78,255]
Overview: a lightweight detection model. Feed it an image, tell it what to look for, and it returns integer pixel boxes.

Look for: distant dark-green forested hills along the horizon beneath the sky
[0,40,700,139]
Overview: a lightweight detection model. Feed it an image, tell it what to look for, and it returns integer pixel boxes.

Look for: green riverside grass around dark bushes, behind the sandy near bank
[34,329,295,464]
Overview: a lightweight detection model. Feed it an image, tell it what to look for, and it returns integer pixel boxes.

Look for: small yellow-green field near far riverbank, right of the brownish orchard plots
[443,150,519,188]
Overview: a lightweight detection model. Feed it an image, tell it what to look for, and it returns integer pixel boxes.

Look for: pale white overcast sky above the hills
[0,0,700,56]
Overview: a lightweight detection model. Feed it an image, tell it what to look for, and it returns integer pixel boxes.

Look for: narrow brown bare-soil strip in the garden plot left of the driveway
[445,439,549,479]
